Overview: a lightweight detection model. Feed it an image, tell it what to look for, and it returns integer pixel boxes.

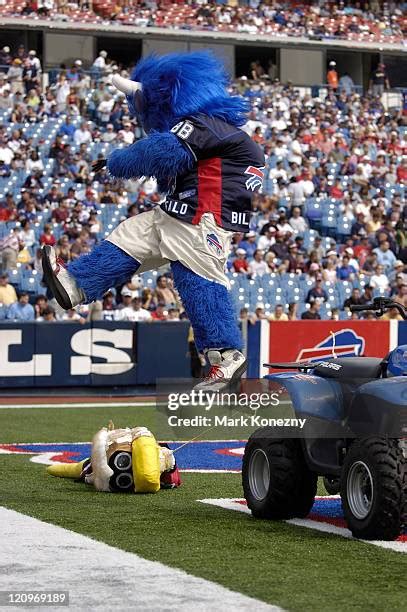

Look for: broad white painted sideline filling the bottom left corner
[0,507,282,612]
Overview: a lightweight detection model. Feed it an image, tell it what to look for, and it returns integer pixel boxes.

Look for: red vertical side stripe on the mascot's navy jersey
[192,157,222,226]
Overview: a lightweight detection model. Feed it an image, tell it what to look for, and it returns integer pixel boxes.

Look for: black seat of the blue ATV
[315,357,383,380]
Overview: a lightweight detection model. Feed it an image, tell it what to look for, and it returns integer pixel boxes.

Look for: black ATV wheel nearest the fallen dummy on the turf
[242,432,317,520]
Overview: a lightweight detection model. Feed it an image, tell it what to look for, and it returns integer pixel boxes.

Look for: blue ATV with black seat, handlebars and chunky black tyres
[242,298,407,540]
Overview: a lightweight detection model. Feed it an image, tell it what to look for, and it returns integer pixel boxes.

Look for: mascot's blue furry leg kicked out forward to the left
[67,240,140,303]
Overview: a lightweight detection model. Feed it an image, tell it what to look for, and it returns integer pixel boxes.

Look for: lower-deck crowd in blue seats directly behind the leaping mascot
[0,46,407,322]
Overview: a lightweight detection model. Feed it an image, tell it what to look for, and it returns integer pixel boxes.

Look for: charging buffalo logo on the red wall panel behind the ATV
[295,329,365,361]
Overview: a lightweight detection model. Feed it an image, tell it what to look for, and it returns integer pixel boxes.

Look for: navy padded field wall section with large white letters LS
[0,321,190,388]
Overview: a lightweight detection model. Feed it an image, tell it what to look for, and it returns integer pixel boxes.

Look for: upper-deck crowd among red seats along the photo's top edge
[0,0,406,43]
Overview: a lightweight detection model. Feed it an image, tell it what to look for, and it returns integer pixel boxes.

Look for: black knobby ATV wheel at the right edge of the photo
[341,438,407,540]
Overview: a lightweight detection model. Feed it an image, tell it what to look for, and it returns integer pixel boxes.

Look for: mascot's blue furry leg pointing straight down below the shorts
[171,261,243,353]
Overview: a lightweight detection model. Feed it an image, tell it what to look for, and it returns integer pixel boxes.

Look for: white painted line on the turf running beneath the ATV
[197,495,407,553]
